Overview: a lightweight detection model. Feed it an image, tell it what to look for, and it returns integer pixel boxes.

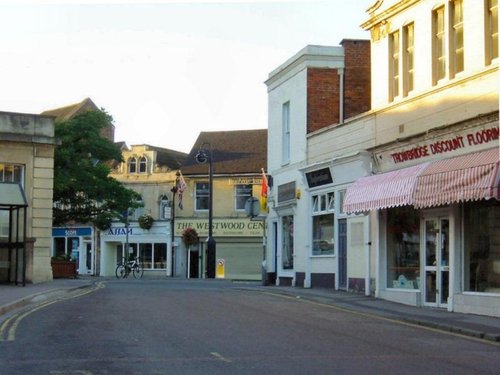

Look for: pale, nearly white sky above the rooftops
[0,0,375,152]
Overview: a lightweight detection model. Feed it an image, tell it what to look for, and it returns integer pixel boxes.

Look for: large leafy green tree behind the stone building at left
[53,110,138,229]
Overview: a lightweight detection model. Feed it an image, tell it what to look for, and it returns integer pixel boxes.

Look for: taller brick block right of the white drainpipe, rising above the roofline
[341,40,371,119]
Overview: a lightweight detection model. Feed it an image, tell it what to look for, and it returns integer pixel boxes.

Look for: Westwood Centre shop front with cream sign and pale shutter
[174,217,264,280]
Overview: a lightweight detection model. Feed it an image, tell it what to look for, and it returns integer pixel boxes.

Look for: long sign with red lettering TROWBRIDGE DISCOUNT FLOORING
[375,125,499,164]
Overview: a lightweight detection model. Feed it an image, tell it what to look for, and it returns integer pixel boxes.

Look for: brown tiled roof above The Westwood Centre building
[181,129,267,175]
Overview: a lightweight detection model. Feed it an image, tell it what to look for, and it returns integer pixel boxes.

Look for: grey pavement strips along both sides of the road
[0,277,500,343]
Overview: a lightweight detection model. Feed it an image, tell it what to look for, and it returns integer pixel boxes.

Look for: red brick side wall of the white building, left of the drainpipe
[307,68,340,133]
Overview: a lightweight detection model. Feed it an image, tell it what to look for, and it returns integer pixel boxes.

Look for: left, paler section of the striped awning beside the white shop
[342,163,429,213]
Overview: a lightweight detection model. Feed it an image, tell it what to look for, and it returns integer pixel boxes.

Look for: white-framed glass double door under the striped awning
[422,217,450,307]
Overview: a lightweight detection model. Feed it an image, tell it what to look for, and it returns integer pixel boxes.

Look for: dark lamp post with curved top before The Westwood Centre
[195,142,216,279]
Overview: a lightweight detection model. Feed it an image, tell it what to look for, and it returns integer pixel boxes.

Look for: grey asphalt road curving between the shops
[0,279,500,375]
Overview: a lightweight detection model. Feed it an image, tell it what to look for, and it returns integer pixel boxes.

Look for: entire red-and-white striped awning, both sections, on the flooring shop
[343,149,500,213]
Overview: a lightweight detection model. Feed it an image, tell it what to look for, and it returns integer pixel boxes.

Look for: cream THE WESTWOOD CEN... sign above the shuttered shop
[175,218,265,237]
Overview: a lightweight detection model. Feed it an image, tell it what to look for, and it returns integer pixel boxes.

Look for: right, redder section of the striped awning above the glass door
[414,149,500,208]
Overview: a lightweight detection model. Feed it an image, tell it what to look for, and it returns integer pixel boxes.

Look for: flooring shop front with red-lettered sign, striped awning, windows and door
[343,121,500,316]
